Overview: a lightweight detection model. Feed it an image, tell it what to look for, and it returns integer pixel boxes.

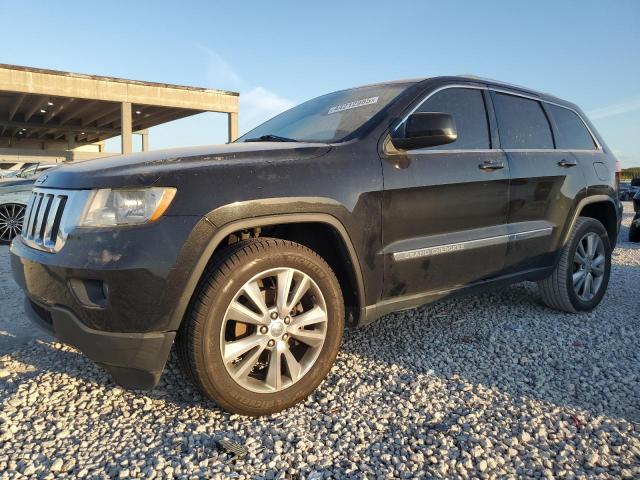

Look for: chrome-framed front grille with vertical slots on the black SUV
[22,188,88,252]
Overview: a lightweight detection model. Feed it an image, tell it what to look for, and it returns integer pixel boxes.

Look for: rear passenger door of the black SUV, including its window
[491,91,586,272]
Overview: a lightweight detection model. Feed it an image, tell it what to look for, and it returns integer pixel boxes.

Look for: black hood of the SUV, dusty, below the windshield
[36,142,331,189]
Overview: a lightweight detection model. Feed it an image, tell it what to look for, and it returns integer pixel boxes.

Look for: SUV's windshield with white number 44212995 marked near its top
[236,83,411,143]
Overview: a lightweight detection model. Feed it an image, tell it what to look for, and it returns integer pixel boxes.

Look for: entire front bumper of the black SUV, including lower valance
[10,217,208,389]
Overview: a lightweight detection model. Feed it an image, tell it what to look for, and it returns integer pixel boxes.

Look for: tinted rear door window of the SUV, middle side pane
[493,93,553,149]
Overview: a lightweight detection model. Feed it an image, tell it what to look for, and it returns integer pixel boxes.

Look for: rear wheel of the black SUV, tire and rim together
[538,217,611,313]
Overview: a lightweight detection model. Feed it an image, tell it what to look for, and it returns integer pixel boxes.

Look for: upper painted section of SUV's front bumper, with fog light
[10,217,198,333]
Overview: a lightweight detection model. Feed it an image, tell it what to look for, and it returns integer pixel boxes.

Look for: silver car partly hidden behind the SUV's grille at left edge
[0,164,57,244]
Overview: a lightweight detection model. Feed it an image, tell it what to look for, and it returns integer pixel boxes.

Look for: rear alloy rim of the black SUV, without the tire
[572,232,606,302]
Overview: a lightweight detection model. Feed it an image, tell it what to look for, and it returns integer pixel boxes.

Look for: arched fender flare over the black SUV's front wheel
[169,213,366,330]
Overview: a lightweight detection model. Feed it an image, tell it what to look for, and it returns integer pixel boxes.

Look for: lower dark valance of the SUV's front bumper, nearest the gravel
[25,297,175,389]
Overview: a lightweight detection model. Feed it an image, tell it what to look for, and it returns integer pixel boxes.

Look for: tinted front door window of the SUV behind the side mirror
[417,88,490,150]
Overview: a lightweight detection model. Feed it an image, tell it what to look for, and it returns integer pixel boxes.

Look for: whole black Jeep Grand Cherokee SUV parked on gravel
[11,77,621,415]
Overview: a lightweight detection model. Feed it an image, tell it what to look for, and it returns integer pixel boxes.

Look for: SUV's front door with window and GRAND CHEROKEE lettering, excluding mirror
[382,86,509,299]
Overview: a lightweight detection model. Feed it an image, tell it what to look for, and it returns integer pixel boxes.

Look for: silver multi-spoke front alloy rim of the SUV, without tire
[220,268,328,393]
